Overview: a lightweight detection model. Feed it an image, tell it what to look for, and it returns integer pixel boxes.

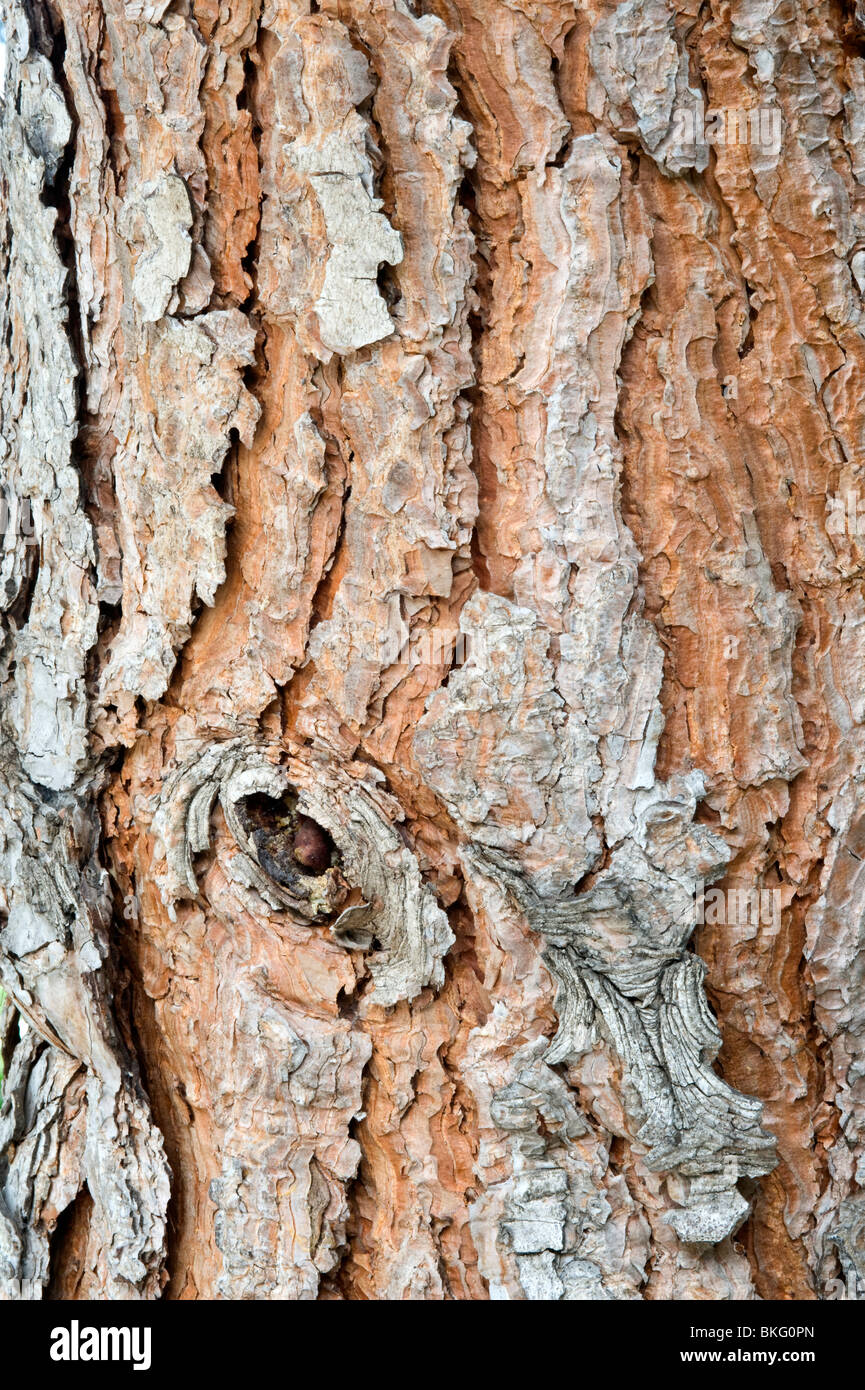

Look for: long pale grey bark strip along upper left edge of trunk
[0,35,97,790]
